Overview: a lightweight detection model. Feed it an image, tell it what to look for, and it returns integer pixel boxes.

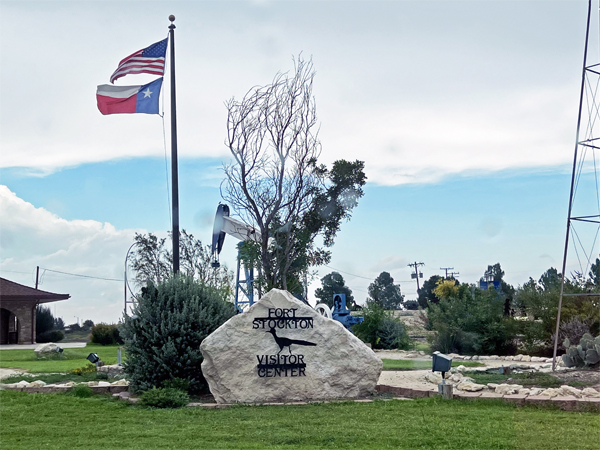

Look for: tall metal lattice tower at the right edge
[552,0,600,370]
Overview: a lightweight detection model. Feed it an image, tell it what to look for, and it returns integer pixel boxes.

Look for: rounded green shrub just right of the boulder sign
[352,302,410,350]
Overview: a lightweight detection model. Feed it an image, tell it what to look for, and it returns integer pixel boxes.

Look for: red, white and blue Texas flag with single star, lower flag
[96,78,163,115]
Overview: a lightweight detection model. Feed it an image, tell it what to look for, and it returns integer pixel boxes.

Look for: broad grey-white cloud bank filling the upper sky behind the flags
[0,1,583,185]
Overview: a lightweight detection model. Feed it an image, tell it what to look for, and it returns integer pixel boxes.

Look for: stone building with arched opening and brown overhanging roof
[0,278,71,344]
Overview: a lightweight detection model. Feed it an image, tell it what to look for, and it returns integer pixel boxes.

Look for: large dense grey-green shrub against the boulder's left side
[121,275,235,394]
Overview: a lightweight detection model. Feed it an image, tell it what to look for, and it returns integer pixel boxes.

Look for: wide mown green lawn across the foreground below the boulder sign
[0,391,600,450]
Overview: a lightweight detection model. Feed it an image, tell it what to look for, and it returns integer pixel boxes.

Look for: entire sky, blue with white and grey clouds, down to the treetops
[0,0,597,322]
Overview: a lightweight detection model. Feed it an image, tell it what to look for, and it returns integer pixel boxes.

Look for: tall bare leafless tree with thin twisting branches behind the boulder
[221,56,326,289]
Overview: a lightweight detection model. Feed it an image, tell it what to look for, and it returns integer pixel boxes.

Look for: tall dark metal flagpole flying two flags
[169,14,179,274]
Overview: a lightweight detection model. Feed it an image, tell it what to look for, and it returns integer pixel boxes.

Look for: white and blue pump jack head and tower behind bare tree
[211,204,261,312]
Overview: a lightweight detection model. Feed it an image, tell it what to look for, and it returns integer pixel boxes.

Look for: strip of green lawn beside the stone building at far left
[0,343,124,373]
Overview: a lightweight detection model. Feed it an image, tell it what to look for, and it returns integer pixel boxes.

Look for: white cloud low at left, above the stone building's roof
[0,186,143,323]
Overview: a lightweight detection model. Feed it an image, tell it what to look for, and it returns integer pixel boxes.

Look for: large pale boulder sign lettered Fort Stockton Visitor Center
[200,289,383,403]
